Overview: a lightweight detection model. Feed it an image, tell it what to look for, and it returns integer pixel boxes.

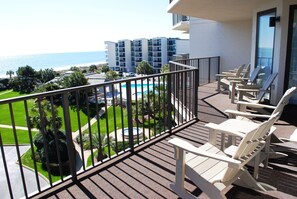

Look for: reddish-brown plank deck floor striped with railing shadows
[31,84,297,199]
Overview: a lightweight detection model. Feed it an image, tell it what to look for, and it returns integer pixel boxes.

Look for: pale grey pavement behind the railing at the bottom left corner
[0,146,48,199]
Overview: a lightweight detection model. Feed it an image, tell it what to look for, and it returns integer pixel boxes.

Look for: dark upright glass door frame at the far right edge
[284,5,297,92]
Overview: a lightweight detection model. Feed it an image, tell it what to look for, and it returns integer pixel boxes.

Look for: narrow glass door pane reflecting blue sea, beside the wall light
[255,9,276,84]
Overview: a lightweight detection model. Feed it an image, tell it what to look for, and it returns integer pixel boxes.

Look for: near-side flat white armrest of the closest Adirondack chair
[168,138,241,168]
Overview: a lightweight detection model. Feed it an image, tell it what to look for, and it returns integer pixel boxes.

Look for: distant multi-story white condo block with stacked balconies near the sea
[105,37,189,73]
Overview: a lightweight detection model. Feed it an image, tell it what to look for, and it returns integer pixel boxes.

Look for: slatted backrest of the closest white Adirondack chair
[222,113,279,182]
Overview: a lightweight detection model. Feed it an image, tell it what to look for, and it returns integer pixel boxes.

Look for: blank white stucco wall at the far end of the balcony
[190,18,252,71]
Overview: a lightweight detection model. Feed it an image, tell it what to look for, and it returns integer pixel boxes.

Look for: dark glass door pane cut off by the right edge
[285,5,297,105]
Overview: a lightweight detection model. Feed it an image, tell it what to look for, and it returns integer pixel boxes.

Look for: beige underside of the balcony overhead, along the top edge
[167,0,271,21]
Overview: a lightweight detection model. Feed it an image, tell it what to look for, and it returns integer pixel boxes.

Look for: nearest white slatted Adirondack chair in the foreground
[169,115,277,199]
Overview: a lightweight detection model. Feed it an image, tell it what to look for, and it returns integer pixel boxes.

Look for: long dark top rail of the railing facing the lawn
[0,69,197,105]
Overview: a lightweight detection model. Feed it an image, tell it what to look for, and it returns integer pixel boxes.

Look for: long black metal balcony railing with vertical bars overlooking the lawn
[0,57,219,198]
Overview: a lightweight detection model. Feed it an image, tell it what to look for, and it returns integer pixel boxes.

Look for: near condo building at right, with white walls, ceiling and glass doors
[168,0,297,104]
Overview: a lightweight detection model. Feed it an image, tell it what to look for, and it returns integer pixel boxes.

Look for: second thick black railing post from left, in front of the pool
[126,81,134,153]
